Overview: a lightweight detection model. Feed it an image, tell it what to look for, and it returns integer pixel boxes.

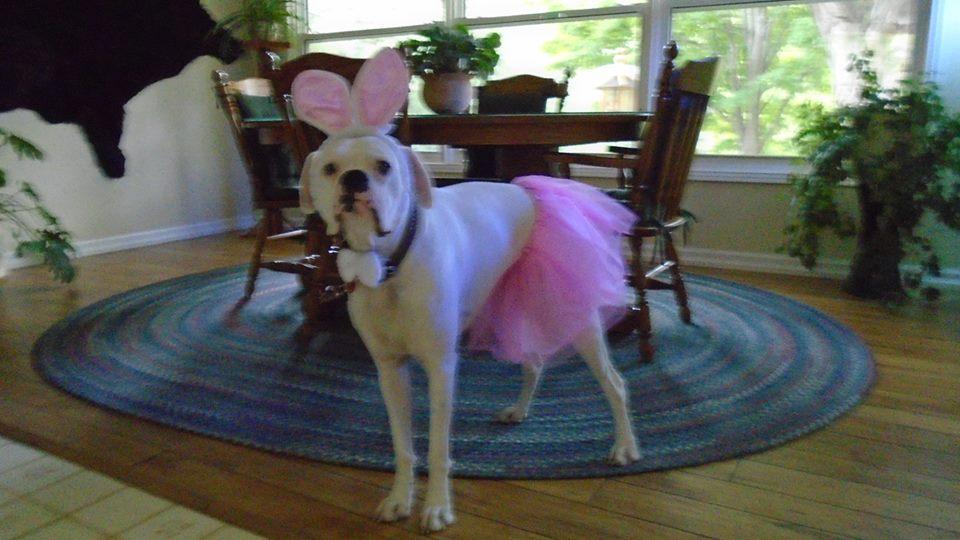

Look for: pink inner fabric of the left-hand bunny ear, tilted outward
[291,70,353,133]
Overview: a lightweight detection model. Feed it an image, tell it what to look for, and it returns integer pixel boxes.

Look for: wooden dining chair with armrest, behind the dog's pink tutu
[547,41,718,362]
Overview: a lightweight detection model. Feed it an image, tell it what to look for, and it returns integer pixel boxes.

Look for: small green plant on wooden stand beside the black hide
[214,0,300,50]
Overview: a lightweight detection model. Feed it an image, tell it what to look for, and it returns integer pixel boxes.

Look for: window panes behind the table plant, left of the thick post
[306,0,641,114]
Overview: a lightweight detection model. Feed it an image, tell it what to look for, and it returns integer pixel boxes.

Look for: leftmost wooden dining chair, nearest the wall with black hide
[212,70,306,300]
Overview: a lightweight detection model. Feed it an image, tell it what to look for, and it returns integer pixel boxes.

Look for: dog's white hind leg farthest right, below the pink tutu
[574,318,640,465]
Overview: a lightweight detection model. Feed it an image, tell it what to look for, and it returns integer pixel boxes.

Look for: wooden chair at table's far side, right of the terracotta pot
[466,74,567,180]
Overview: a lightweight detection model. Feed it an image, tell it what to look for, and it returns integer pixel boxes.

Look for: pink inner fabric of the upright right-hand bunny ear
[353,49,410,126]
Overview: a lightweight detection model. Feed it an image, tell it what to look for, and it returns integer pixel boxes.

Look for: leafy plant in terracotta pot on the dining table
[397,24,500,114]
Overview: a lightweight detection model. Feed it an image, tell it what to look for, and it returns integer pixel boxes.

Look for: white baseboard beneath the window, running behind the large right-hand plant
[679,246,960,288]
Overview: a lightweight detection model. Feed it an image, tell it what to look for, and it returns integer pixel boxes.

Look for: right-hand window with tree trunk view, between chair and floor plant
[671,0,917,156]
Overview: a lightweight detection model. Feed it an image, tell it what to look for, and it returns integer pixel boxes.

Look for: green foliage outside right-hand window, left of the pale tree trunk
[673,5,832,155]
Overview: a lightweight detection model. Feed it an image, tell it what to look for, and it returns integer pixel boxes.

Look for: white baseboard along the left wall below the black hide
[0,214,256,269]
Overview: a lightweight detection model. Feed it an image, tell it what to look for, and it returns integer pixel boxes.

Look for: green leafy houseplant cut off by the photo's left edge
[0,129,77,283]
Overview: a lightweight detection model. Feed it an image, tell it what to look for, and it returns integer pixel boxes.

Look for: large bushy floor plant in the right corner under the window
[784,53,960,300]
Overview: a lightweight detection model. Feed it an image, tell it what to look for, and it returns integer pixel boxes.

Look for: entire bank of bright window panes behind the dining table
[305,0,930,180]
